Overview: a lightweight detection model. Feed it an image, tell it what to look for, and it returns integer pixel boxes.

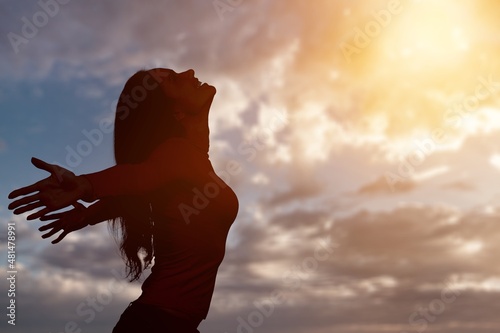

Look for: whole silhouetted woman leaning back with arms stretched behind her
[9,68,238,333]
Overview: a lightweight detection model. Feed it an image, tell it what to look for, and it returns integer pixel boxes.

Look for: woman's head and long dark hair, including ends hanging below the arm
[113,68,215,280]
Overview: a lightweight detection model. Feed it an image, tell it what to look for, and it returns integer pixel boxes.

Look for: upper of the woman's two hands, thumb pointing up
[8,157,92,220]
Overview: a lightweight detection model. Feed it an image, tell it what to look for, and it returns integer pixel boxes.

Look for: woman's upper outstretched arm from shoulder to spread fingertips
[8,139,199,220]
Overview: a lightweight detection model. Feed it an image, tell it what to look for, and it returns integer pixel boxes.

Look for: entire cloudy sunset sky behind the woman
[0,0,500,333]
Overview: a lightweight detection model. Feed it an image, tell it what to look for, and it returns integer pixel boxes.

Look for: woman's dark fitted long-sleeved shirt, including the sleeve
[85,138,238,320]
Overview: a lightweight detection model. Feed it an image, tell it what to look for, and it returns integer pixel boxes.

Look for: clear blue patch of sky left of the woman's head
[0,74,119,216]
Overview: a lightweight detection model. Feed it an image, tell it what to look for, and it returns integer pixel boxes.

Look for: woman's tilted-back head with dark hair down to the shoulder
[114,68,216,164]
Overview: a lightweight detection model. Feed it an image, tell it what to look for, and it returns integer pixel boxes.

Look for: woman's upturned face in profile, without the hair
[151,69,216,114]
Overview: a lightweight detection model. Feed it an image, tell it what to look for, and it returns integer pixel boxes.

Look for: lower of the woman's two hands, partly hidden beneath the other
[38,202,89,244]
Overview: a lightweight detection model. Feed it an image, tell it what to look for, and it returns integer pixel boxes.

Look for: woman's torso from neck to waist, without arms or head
[138,146,238,320]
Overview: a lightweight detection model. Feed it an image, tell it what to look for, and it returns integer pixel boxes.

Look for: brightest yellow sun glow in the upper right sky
[334,0,500,157]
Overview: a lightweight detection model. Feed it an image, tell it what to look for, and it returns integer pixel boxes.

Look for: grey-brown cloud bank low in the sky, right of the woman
[207,205,500,332]
